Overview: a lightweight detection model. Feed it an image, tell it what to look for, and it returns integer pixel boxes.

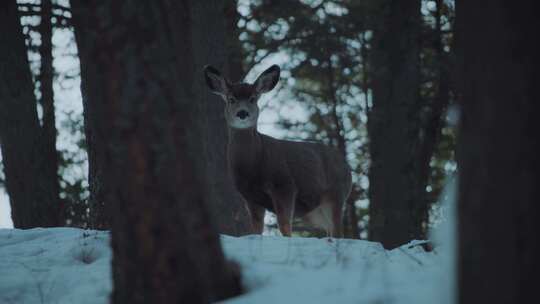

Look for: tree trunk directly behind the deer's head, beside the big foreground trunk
[193,1,251,235]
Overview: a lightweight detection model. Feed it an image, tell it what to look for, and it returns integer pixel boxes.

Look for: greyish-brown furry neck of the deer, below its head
[228,128,262,174]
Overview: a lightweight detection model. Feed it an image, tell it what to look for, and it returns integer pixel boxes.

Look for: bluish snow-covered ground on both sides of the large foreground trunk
[0,228,450,304]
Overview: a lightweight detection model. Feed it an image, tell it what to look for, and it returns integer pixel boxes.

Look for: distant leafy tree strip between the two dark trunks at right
[418,0,456,218]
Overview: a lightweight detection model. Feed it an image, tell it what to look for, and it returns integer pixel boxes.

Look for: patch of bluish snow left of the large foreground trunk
[0,228,111,304]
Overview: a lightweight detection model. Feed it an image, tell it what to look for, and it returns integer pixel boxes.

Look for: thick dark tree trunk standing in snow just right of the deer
[368,0,427,248]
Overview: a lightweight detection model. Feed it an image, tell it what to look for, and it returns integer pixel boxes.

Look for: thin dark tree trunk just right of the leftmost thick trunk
[39,0,63,224]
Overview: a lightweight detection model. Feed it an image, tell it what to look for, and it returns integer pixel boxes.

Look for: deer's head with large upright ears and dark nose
[204,65,280,129]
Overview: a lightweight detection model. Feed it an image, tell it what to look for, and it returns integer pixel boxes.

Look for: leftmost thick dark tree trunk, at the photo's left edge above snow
[0,0,61,228]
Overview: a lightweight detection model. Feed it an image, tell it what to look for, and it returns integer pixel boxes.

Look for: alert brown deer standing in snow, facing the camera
[204,65,352,237]
